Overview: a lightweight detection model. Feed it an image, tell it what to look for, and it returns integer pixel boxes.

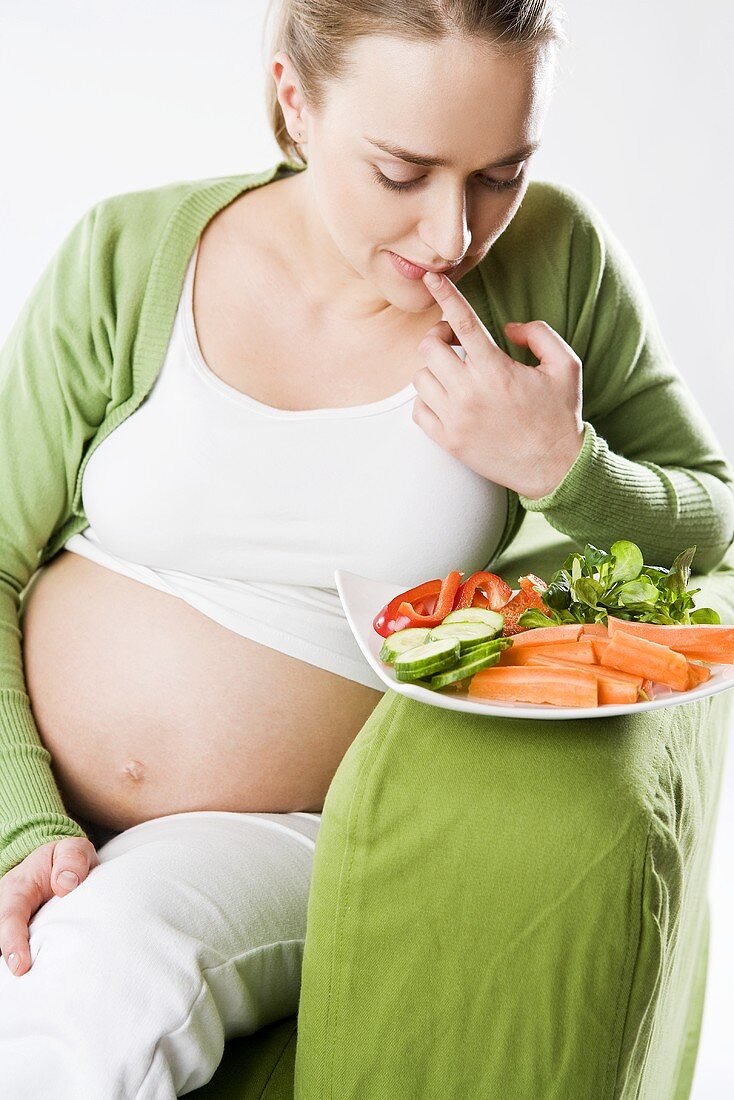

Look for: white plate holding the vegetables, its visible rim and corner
[333,569,734,721]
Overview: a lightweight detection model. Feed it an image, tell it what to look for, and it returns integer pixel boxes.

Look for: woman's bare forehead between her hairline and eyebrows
[327,35,551,165]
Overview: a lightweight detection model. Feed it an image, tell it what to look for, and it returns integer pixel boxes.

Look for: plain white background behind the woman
[0,0,734,1100]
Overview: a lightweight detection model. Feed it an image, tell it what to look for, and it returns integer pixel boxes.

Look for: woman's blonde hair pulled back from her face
[263,0,569,166]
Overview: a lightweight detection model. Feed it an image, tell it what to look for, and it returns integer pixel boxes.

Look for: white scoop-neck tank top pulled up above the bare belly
[65,243,507,691]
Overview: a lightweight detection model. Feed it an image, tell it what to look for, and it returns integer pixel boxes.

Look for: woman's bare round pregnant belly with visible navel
[21,551,382,829]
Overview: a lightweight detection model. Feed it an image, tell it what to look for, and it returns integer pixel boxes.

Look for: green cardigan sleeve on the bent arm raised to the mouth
[513,185,734,573]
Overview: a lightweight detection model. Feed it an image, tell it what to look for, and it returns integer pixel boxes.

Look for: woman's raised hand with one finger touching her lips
[413,274,584,499]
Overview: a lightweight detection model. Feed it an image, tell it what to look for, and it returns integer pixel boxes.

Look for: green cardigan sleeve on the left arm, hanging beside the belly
[0,207,112,876]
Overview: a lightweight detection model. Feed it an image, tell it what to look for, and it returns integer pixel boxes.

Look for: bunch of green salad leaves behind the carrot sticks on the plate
[518,539,721,627]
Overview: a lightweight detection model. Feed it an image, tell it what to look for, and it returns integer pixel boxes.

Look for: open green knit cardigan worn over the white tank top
[0,161,734,876]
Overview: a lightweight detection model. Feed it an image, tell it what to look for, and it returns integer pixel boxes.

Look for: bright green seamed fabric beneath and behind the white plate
[189,514,734,1100]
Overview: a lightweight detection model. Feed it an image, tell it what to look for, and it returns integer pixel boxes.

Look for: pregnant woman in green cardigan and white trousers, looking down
[0,0,734,1100]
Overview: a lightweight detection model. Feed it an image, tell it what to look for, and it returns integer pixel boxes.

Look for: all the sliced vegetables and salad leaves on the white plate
[372,539,734,707]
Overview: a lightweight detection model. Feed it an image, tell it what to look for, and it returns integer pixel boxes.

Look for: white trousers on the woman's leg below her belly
[0,811,321,1100]
